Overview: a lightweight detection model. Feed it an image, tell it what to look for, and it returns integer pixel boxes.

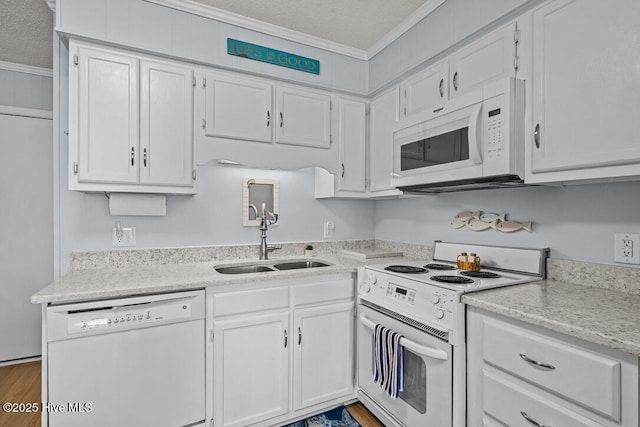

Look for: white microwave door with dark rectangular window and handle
[392,96,482,186]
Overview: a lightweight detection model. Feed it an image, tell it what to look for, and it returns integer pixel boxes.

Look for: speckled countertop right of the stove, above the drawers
[462,280,640,356]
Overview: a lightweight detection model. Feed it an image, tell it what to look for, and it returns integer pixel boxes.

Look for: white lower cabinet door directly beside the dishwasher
[213,312,293,427]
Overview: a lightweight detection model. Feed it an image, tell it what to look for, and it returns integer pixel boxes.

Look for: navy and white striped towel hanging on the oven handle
[373,324,404,399]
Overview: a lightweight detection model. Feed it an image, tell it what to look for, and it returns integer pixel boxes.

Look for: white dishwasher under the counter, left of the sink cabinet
[42,290,205,427]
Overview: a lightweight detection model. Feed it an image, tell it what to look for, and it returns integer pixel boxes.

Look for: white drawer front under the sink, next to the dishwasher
[213,286,289,317]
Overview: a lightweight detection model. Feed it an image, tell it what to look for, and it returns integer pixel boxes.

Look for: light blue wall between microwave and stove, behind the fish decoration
[375,182,640,264]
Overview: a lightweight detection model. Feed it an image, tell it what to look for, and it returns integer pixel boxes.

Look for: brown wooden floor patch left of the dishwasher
[0,362,42,427]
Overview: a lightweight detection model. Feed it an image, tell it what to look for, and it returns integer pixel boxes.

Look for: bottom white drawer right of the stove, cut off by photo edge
[483,371,602,427]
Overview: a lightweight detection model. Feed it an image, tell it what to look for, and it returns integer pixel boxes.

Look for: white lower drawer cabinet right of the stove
[467,308,638,427]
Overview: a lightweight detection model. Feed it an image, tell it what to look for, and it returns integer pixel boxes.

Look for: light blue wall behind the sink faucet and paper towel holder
[60,161,375,273]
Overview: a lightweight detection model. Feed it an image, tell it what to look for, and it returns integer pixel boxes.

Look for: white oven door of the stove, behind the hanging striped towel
[358,304,453,427]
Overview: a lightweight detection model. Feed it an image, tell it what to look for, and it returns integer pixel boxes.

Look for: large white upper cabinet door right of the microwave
[531,0,640,178]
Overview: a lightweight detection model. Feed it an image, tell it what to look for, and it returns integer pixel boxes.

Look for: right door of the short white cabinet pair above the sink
[276,86,331,148]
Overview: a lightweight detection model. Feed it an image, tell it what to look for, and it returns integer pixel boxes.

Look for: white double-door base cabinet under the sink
[207,274,355,427]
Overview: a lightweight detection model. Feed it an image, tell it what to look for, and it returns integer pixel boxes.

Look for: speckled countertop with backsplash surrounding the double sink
[31,241,431,304]
